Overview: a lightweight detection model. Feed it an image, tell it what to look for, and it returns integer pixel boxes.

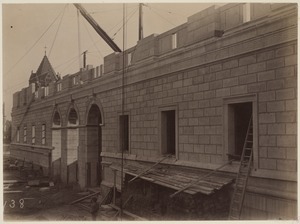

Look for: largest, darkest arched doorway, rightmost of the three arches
[86,104,102,187]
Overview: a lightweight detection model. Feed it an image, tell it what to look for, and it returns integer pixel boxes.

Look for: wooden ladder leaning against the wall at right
[228,116,253,220]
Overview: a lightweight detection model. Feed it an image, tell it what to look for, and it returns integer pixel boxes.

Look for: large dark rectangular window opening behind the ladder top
[228,102,253,160]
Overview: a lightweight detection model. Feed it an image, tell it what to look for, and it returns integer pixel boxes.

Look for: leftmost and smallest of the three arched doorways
[52,111,61,179]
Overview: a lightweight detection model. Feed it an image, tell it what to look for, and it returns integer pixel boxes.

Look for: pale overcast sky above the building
[2,3,223,119]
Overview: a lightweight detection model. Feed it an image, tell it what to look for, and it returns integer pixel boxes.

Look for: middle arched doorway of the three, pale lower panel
[67,108,79,183]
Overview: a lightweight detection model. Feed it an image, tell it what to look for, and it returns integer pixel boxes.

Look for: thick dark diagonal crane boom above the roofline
[74,3,122,52]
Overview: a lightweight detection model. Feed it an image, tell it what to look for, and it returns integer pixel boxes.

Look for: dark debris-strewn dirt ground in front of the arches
[3,146,117,221]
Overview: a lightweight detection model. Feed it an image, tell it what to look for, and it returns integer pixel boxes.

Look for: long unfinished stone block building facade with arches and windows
[11,4,297,219]
